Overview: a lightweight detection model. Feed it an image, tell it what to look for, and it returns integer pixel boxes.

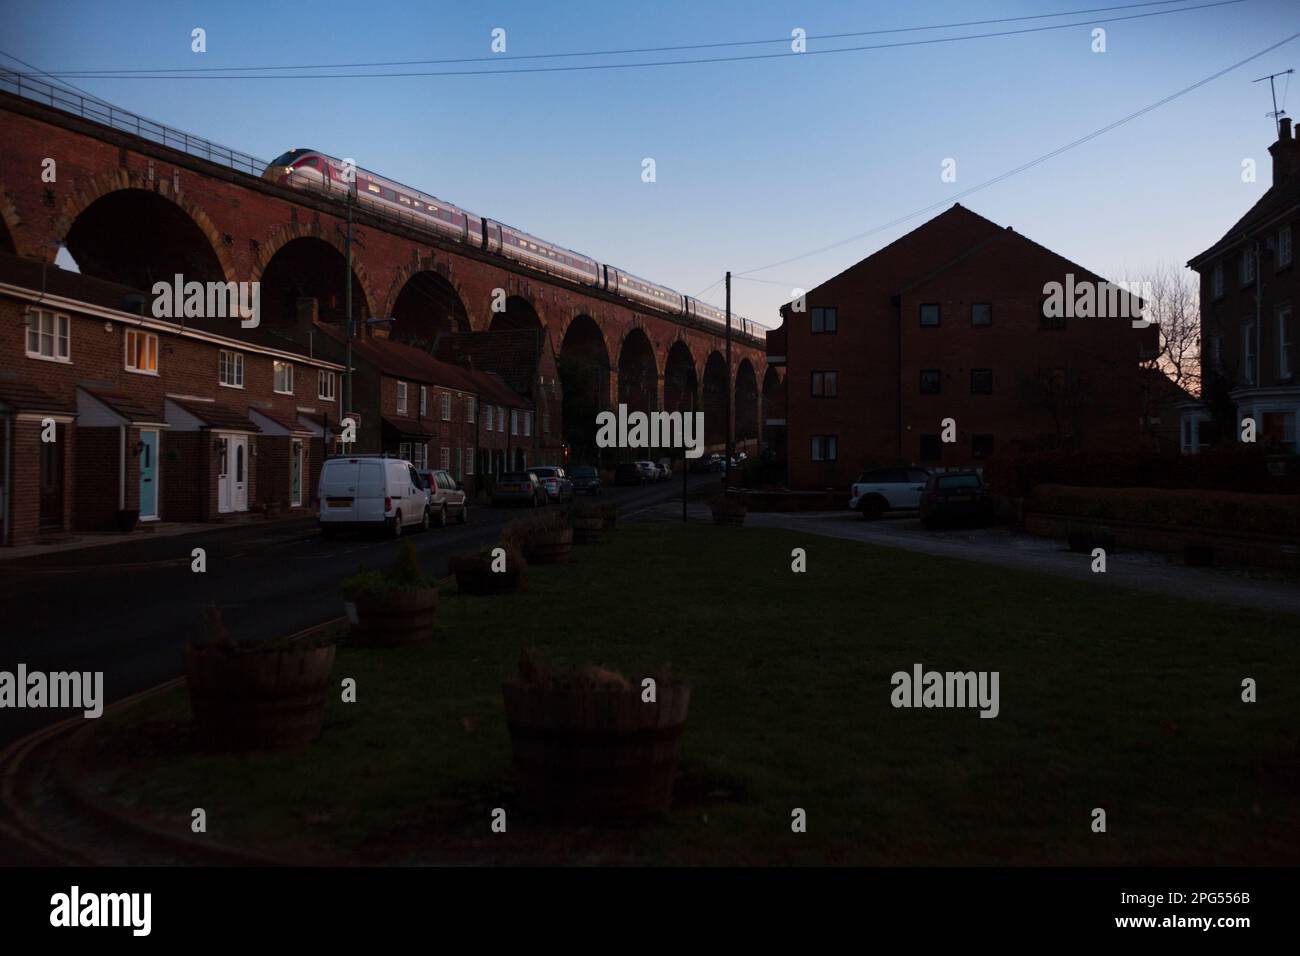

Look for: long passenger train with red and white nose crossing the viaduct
[263,150,766,339]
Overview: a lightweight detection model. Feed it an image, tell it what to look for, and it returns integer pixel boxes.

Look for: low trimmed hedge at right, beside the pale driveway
[1027,485,1300,540]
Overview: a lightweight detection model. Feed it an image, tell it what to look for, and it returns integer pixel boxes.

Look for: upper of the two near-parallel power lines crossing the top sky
[32,0,1188,77]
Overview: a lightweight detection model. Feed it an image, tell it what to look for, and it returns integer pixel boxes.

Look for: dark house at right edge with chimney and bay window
[1180,117,1300,455]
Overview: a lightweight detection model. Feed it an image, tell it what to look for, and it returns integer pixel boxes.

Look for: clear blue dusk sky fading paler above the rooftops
[0,0,1300,326]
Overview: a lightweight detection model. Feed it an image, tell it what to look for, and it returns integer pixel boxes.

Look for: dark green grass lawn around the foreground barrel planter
[90,524,1300,865]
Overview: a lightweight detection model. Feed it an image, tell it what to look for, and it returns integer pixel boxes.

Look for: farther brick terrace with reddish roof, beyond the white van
[317,324,534,493]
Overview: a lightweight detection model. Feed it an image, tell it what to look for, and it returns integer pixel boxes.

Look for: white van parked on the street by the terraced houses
[319,455,430,537]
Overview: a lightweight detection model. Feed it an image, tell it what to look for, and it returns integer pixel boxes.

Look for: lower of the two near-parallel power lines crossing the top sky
[30,0,1245,79]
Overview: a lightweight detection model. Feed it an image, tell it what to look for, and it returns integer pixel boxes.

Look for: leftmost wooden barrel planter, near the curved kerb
[185,644,334,750]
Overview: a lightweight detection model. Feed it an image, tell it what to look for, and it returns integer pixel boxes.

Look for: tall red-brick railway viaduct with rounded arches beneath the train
[0,79,780,447]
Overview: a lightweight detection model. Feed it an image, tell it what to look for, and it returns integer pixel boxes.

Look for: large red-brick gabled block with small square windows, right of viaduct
[766,204,1158,488]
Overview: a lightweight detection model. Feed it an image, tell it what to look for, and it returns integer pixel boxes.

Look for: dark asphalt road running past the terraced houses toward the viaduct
[0,475,718,747]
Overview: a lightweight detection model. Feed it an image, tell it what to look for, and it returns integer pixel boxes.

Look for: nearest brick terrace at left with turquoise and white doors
[0,254,342,545]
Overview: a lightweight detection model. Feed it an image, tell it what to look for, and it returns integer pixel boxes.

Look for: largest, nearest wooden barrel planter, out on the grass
[503,683,690,819]
